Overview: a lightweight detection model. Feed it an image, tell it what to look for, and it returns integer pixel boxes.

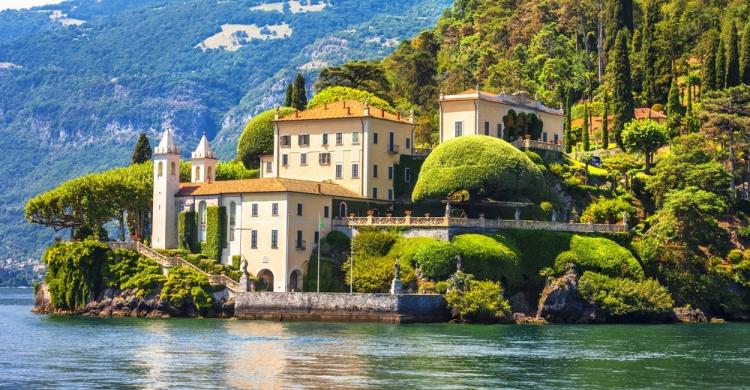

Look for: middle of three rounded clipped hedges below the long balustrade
[452,234,523,287]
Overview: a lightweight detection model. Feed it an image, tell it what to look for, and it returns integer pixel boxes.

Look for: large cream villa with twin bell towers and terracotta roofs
[151,101,414,291]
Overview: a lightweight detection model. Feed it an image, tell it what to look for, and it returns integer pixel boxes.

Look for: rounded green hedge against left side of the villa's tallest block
[237,107,294,169]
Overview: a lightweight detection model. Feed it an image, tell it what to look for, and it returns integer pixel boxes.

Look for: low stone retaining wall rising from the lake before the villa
[234,292,450,324]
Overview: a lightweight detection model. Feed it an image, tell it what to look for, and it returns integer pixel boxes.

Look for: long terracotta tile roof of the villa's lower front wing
[177,178,364,199]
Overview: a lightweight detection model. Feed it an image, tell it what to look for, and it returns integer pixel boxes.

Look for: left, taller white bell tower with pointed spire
[151,128,180,249]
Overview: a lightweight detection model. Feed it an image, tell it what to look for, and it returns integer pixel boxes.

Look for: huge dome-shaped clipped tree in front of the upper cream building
[412,135,546,202]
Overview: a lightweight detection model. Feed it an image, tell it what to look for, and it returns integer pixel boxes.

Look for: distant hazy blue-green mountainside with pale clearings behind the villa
[0,0,450,264]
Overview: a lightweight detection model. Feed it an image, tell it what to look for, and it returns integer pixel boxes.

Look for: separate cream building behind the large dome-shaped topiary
[439,89,564,145]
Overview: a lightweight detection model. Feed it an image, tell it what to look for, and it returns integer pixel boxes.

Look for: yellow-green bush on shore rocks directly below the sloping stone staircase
[161,267,213,310]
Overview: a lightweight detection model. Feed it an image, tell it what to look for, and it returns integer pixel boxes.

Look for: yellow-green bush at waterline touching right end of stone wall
[445,280,510,322]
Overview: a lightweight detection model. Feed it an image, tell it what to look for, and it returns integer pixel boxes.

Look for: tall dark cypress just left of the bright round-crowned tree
[611,29,635,149]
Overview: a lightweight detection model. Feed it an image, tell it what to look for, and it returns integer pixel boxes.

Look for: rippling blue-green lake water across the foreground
[0,289,750,389]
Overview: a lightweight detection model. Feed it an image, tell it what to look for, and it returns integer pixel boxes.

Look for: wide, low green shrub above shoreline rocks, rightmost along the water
[577,272,674,319]
